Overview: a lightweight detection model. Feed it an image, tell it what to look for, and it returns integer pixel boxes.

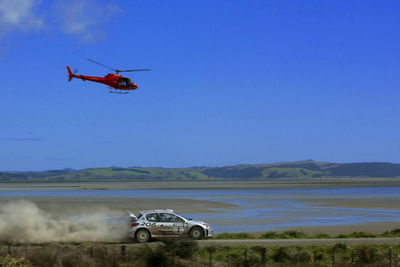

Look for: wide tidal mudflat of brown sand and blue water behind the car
[0,179,400,234]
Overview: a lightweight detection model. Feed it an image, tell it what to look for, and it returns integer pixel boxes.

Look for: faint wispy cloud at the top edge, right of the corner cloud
[55,0,121,42]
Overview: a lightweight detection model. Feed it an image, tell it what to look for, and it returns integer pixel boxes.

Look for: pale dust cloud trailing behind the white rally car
[0,200,128,243]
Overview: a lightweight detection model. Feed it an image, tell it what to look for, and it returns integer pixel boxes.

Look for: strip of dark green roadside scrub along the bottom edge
[0,243,400,267]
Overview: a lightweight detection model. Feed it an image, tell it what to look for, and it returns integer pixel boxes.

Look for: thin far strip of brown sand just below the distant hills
[0,178,400,190]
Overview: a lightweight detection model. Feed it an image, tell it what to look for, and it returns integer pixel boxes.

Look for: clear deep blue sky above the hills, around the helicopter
[0,0,400,170]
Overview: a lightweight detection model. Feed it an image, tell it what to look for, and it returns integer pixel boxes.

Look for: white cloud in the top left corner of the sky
[0,0,43,33]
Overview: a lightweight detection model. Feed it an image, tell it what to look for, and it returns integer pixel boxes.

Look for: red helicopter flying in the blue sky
[67,59,151,94]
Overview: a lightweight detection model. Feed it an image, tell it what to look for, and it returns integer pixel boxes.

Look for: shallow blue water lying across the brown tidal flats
[0,187,400,233]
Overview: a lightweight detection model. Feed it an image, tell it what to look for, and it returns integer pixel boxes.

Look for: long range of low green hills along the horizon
[0,160,400,181]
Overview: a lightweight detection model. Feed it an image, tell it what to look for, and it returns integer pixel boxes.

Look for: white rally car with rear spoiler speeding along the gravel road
[127,209,213,243]
